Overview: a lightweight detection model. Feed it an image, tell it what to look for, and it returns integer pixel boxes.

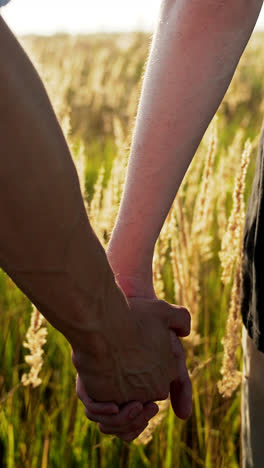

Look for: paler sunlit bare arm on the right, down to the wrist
[107,0,263,294]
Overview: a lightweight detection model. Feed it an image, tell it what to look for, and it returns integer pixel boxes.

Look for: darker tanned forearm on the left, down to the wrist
[0,17,128,350]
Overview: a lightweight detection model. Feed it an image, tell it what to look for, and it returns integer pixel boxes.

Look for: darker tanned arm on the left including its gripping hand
[0,10,191,442]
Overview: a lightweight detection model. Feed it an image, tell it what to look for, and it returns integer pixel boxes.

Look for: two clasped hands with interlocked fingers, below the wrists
[72,286,192,441]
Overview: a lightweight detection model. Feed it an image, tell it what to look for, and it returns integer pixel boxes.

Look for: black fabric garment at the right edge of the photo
[241,122,264,352]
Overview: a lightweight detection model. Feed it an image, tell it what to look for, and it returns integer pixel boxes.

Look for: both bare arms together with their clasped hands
[0,0,262,440]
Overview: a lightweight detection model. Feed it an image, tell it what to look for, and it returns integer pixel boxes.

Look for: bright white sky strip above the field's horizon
[2,0,264,34]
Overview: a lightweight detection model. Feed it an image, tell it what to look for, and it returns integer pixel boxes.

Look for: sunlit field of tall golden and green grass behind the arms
[0,32,264,468]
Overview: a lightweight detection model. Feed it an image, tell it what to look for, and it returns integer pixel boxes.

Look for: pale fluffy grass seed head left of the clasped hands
[21,306,48,388]
